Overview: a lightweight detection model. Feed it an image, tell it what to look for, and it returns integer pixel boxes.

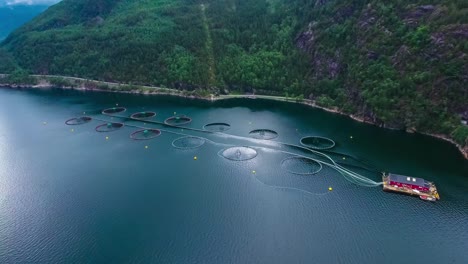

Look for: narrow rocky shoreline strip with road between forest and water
[0,74,468,160]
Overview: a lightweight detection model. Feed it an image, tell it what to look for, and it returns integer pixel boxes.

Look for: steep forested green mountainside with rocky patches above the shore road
[0,0,468,146]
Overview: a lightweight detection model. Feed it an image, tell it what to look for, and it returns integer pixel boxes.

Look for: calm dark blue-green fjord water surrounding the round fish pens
[0,89,468,263]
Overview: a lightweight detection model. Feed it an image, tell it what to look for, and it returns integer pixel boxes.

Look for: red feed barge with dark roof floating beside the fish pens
[382,173,440,202]
